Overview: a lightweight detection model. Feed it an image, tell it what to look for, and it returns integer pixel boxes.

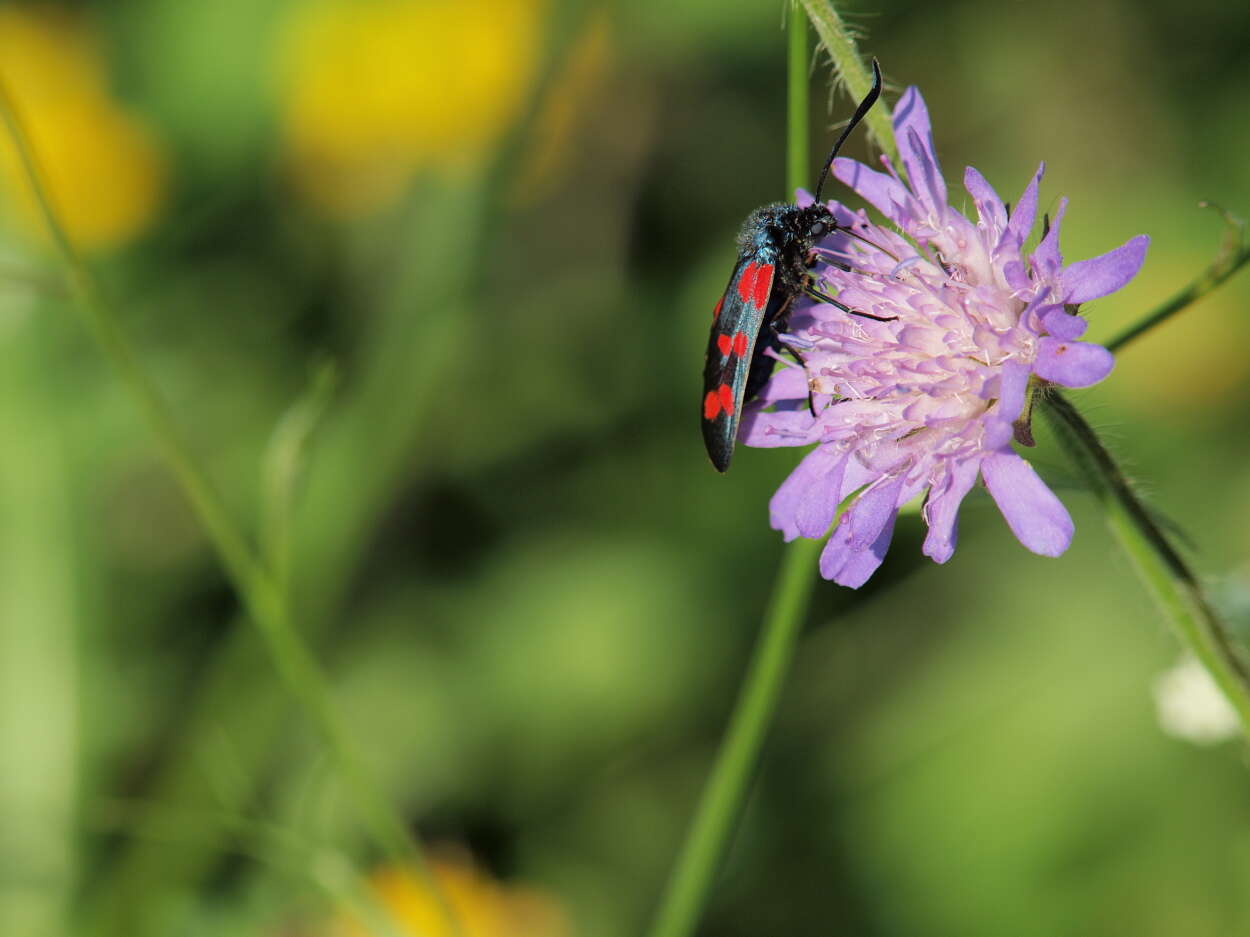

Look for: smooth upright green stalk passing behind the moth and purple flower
[649,16,824,937]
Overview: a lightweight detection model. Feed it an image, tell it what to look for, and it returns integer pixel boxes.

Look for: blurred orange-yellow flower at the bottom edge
[335,852,569,937]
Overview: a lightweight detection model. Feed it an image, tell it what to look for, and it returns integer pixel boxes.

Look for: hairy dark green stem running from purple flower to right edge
[1043,392,1250,738]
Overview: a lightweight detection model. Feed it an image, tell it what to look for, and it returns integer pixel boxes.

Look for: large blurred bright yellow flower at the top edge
[279,0,544,214]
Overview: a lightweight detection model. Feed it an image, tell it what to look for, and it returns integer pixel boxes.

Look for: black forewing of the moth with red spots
[703,252,785,472]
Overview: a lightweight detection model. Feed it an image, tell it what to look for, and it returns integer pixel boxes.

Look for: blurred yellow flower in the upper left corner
[0,6,165,249]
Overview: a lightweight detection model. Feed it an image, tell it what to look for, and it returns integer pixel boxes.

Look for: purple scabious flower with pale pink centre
[741,87,1149,587]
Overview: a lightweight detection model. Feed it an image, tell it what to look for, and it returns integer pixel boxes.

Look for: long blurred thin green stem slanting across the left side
[0,77,461,935]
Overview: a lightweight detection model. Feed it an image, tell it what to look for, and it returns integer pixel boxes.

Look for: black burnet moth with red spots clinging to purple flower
[703,59,881,472]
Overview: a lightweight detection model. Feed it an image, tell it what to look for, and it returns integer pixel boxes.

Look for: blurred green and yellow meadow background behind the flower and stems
[0,0,1250,937]
